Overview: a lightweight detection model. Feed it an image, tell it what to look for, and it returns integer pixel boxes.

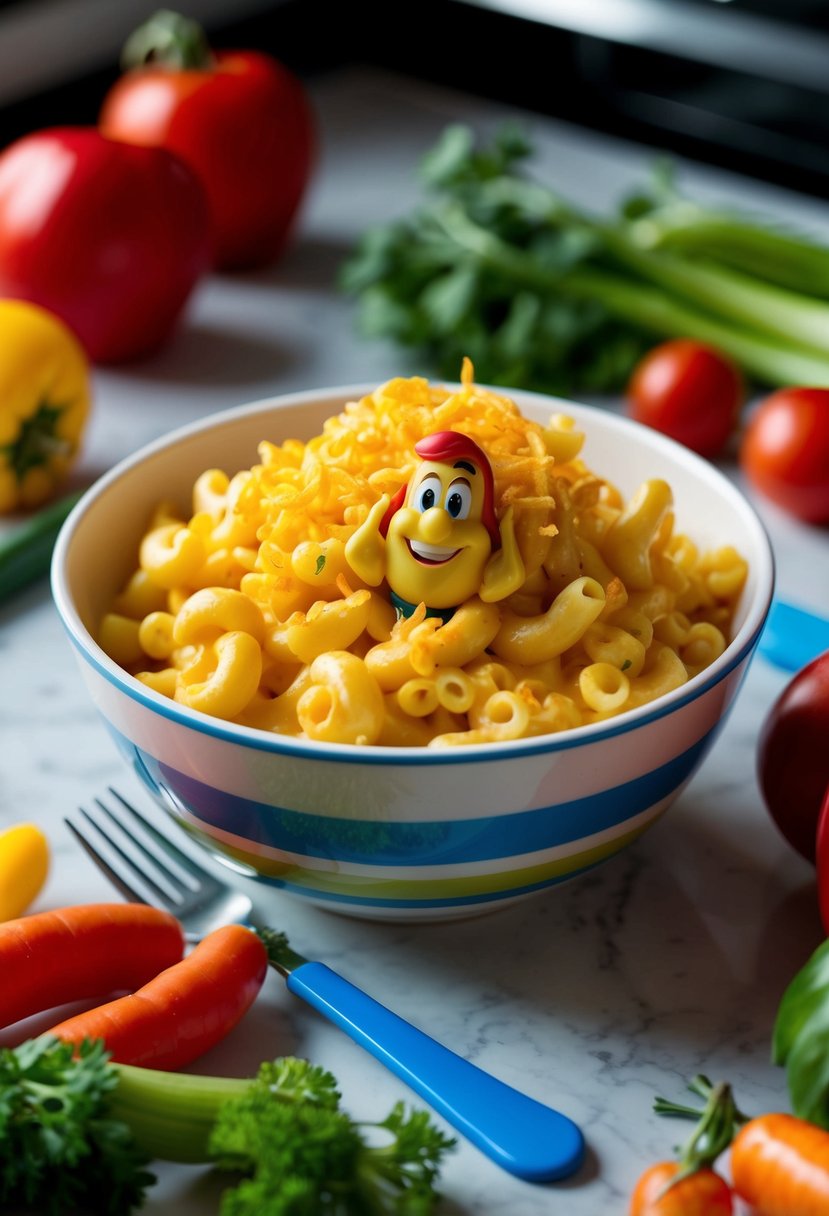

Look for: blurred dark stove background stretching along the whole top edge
[0,0,829,197]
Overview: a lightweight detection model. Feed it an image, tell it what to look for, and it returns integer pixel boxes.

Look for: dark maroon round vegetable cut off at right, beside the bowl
[757,651,829,861]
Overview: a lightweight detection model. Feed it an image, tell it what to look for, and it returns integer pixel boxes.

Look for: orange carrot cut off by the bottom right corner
[731,1114,829,1216]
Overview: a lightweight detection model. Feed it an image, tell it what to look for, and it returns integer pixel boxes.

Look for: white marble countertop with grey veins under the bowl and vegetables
[0,71,829,1216]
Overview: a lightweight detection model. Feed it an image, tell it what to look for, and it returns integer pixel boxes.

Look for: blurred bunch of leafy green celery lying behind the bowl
[342,125,829,393]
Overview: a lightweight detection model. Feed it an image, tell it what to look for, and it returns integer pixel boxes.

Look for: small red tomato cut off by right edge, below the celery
[740,388,829,524]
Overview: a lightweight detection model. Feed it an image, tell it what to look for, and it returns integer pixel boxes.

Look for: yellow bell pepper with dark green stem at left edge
[0,299,91,514]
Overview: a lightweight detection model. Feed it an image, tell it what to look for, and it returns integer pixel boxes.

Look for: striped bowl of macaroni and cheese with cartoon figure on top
[52,366,773,919]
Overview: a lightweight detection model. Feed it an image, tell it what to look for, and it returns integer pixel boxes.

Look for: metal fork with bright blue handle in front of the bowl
[64,789,585,1182]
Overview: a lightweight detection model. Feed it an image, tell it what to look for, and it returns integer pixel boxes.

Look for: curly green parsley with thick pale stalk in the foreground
[0,1036,452,1216]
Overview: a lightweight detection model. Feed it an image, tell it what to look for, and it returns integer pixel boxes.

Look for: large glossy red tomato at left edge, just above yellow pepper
[0,126,209,362]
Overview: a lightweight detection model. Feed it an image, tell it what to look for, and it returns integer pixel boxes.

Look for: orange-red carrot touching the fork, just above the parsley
[49,924,267,1069]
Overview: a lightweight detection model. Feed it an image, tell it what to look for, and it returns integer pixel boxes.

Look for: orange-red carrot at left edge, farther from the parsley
[0,903,185,1026]
